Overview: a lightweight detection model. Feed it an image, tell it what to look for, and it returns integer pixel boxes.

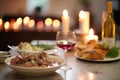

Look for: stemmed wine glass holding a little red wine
[56,31,76,71]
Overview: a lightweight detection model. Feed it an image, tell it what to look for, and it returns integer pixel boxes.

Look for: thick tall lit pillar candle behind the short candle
[79,11,90,34]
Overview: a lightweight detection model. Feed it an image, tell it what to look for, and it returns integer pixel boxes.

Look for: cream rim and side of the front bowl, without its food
[5,55,65,76]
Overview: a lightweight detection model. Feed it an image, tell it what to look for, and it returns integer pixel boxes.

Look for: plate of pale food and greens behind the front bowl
[8,42,57,54]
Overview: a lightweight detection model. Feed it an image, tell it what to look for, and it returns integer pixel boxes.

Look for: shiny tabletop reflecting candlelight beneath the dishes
[0,41,120,80]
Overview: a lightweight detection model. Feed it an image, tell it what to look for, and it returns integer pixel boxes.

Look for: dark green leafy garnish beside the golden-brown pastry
[106,47,120,58]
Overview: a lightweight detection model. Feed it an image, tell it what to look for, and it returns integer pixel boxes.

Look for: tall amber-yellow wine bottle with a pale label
[102,1,116,48]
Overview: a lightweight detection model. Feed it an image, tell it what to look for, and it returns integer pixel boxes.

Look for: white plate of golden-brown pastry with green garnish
[75,40,120,62]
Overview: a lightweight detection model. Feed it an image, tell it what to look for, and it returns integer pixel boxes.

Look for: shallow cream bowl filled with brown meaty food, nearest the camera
[5,53,65,76]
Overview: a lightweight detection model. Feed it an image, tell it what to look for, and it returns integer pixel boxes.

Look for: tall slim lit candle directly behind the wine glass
[62,10,70,33]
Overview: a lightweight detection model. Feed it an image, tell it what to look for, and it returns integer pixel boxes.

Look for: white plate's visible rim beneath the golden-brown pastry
[75,53,120,62]
